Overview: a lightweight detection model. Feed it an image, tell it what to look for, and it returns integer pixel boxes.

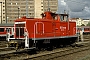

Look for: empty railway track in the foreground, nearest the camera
[23,45,90,60]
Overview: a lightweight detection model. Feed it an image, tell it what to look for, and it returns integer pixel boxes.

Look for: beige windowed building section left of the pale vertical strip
[6,0,35,23]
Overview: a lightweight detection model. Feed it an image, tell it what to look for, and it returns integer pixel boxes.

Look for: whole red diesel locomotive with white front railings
[8,11,77,49]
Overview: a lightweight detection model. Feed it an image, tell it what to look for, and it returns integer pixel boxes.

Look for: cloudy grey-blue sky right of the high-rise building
[57,0,90,19]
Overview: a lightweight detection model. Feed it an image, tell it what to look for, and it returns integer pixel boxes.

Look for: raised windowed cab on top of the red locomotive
[41,11,68,22]
